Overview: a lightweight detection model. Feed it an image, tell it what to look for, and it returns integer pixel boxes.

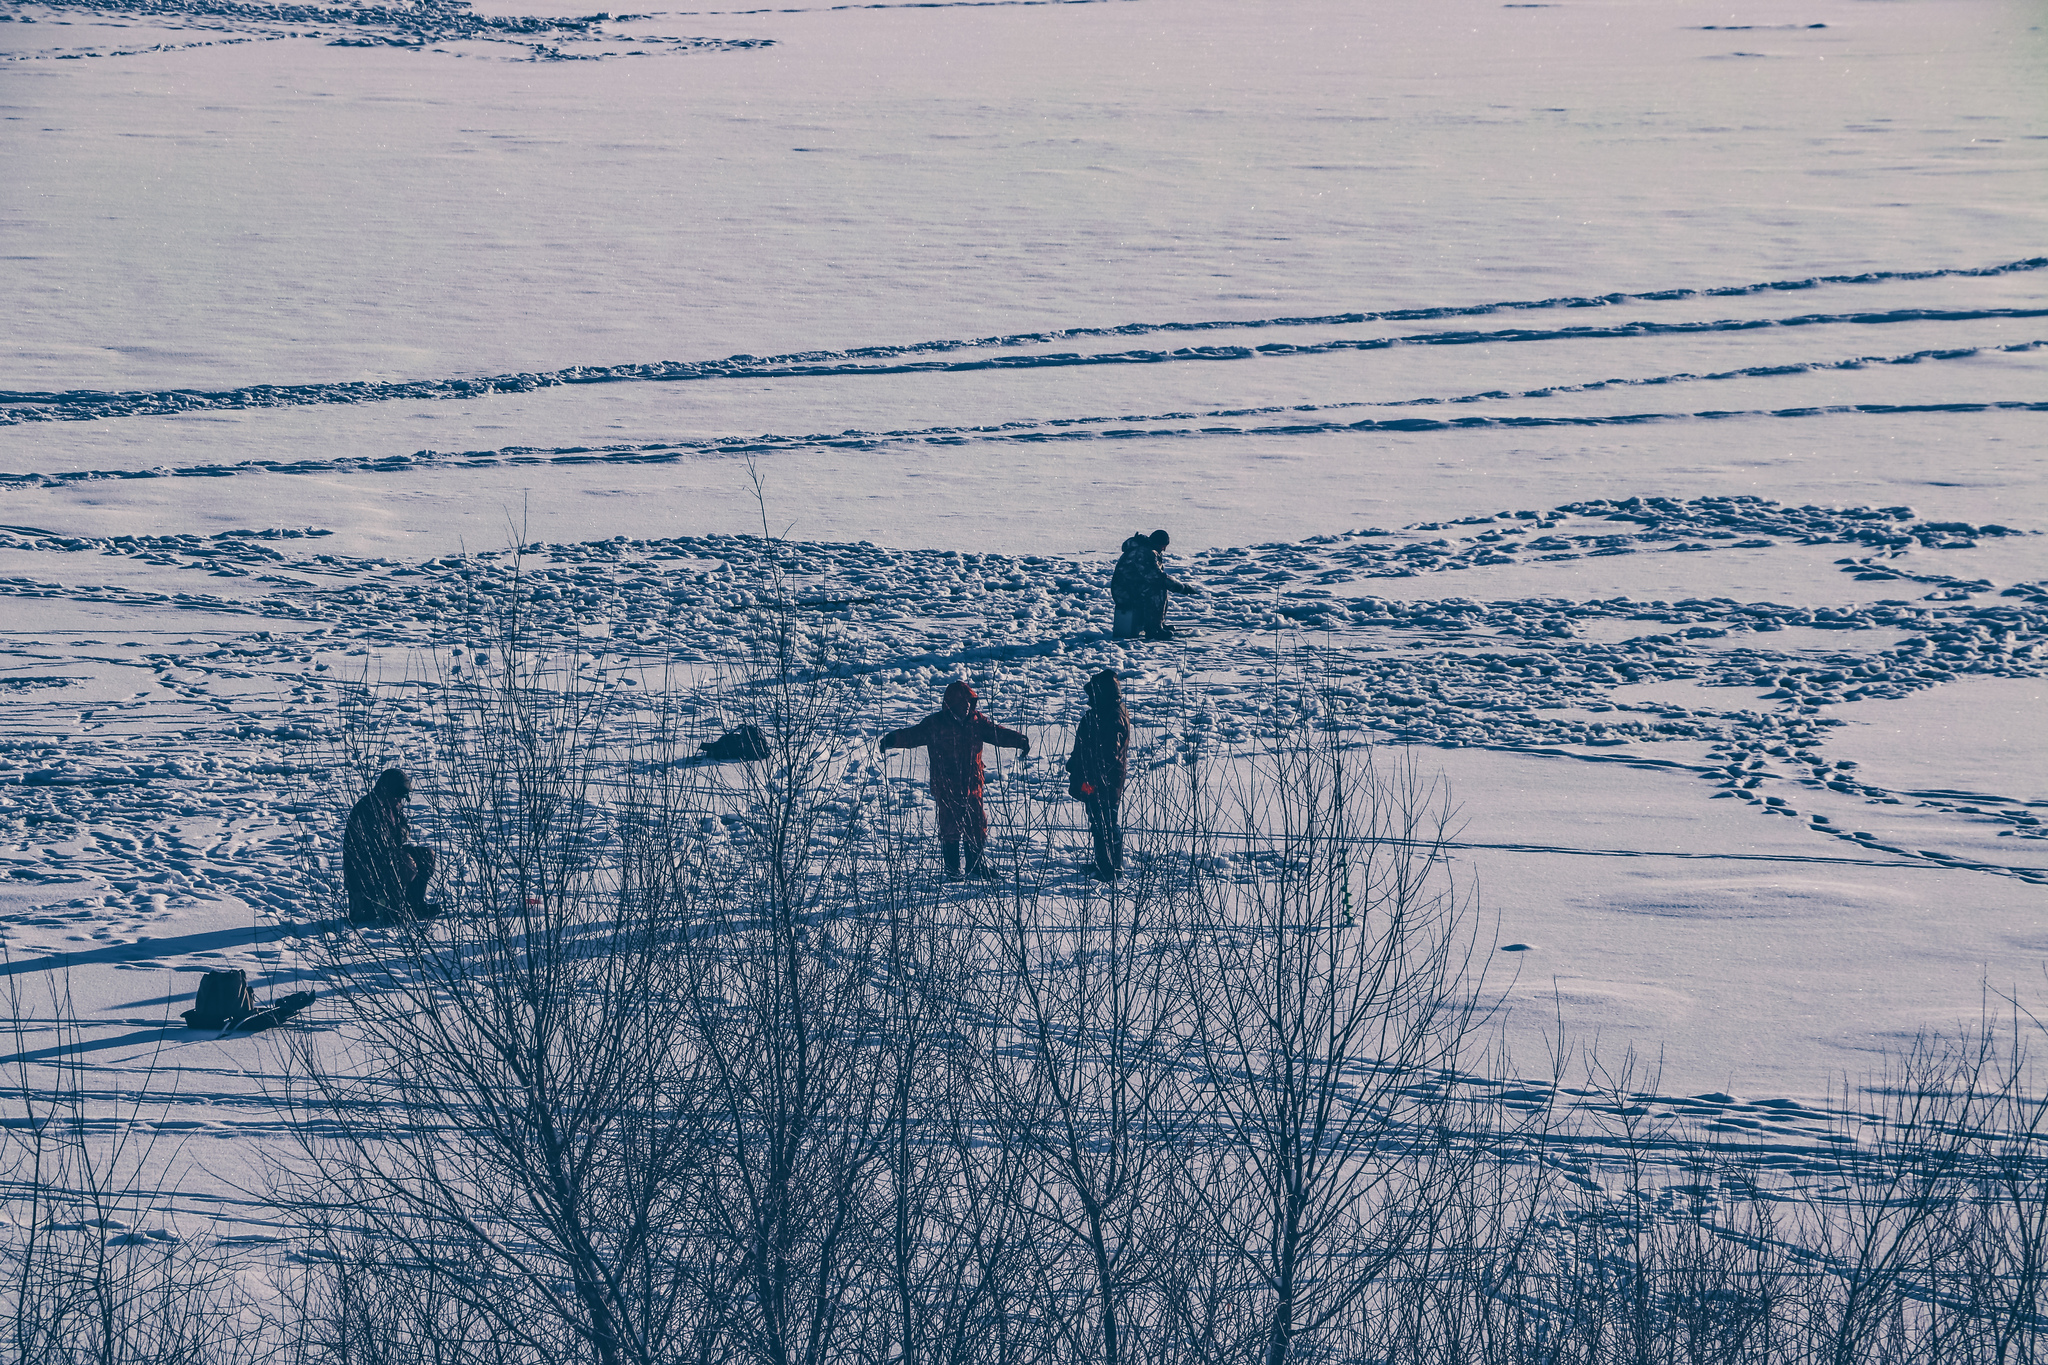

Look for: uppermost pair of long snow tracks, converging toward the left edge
[0,280,2048,426]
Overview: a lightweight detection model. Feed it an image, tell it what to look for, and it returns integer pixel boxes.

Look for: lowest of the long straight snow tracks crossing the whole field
[0,399,2048,489]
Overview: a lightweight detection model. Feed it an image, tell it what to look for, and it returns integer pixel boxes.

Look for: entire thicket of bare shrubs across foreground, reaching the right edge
[260,589,2048,1365]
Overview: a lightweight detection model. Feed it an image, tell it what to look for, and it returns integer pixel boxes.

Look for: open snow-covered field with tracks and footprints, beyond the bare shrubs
[0,0,2048,1236]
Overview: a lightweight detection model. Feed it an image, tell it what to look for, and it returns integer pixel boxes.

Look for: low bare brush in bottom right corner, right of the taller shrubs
[1382,1017,2048,1365]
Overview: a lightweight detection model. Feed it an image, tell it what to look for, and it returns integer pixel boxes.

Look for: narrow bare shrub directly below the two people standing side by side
[971,782,1196,1365]
